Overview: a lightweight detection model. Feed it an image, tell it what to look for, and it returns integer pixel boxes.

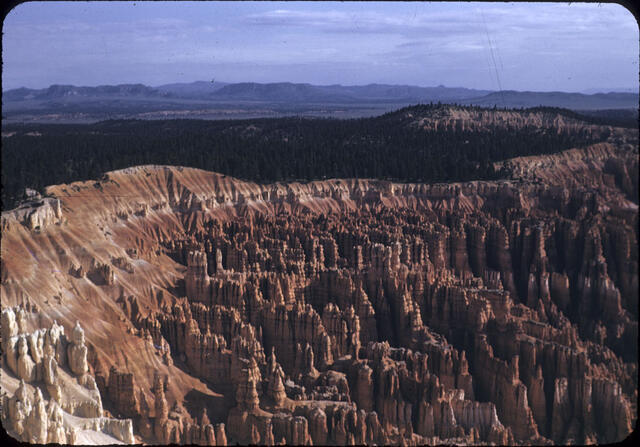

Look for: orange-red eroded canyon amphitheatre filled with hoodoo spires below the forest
[1,130,638,445]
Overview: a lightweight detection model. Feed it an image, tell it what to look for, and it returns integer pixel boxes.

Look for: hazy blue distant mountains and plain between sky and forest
[2,81,638,122]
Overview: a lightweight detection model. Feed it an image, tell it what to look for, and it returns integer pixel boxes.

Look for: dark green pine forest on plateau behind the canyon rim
[2,105,607,210]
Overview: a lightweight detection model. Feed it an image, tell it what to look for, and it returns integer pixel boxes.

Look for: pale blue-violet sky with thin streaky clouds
[2,1,639,91]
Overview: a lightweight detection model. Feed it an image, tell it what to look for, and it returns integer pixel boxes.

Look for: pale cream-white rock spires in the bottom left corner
[0,316,135,444]
